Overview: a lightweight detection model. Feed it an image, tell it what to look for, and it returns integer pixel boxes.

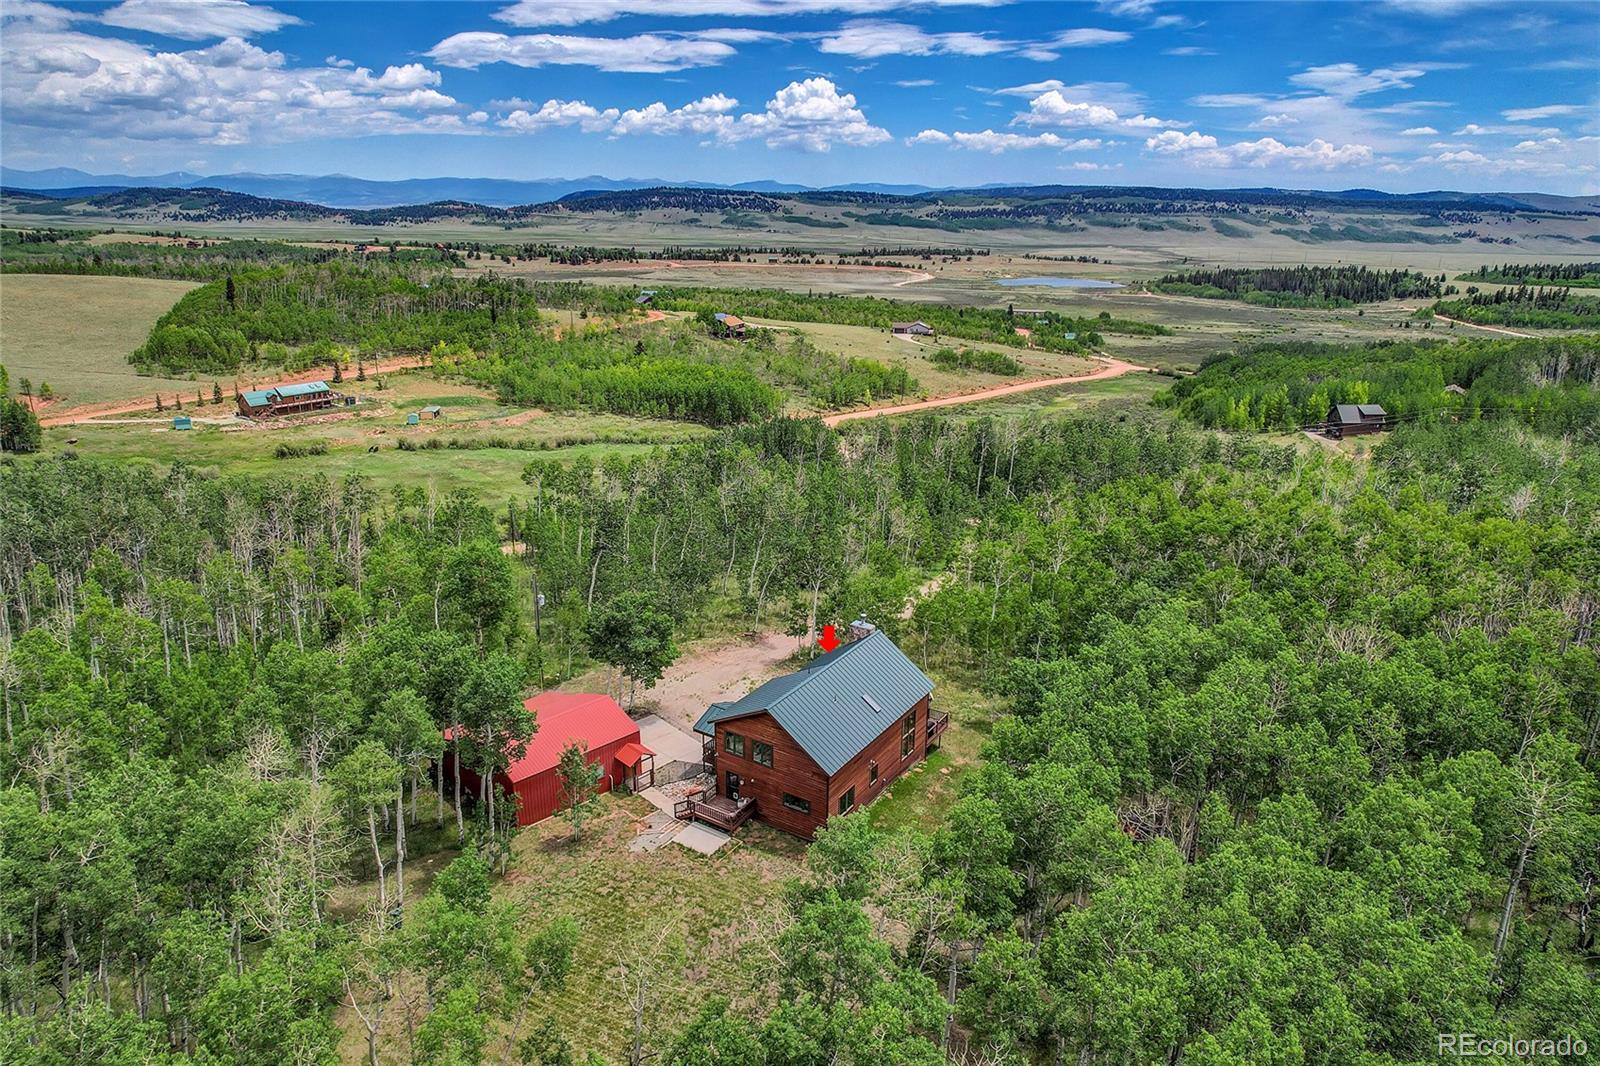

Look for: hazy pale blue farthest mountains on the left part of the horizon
[0,166,933,208]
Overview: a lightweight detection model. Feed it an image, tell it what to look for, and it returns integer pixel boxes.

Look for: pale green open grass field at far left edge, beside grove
[0,274,210,403]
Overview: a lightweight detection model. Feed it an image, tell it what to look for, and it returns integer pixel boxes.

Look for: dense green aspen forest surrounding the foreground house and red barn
[0,396,1600,1066]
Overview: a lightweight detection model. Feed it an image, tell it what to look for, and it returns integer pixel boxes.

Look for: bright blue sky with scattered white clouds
[0,0,1600,194]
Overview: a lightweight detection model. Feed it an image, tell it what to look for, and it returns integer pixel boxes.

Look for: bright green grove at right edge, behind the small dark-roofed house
[1157,336,1600,428]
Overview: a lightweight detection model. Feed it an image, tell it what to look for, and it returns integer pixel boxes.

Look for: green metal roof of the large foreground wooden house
[694,631,933,775]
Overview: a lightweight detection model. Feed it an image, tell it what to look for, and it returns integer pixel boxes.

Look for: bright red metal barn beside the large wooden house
[445,691,656,826]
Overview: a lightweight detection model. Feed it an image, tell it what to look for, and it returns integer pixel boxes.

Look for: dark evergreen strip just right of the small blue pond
[1150,266,1454,307]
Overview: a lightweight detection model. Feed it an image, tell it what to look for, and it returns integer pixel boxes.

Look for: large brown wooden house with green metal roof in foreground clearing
[683,623,949,840]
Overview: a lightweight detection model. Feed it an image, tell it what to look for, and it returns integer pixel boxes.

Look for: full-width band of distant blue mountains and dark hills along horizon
[0,168,1600,228]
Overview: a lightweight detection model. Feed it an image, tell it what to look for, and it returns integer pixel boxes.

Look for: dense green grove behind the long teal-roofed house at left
[130,262,538,373]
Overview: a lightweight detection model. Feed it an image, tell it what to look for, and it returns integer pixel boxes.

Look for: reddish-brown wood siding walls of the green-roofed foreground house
[715,696,928,840]
